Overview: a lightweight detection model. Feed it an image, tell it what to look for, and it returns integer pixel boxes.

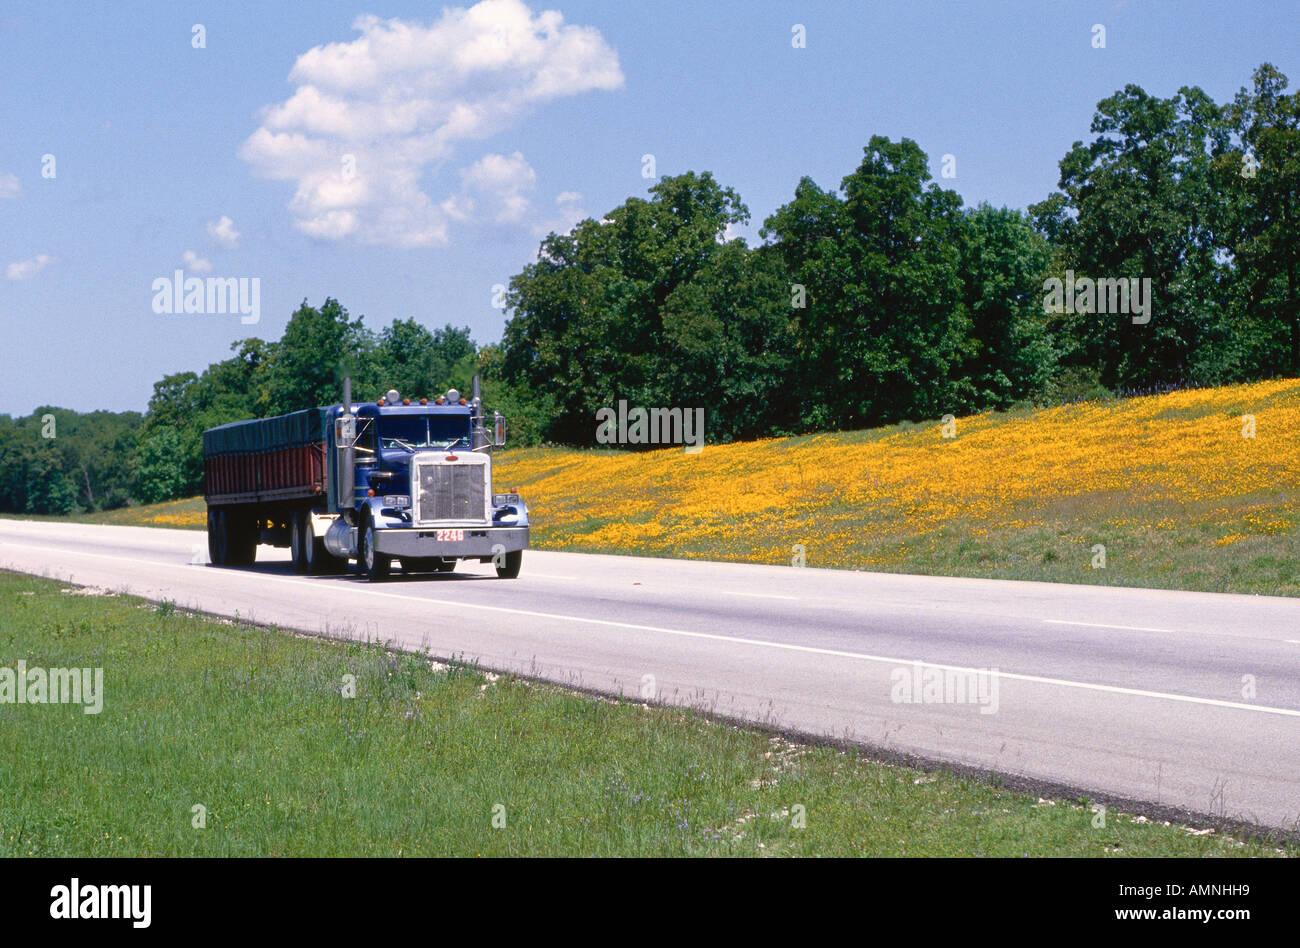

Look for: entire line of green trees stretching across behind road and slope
[0,64,1300,512]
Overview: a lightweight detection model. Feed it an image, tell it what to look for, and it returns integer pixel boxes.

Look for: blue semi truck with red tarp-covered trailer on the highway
[203,377,528,581]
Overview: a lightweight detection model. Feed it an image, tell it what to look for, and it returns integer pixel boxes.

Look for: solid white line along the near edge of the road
[9,544,1300,718]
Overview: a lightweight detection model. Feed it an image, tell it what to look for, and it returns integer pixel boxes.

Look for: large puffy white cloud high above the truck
[241,0,623,247]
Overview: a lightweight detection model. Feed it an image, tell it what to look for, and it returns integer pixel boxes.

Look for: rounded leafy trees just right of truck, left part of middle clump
[502,172,792,443]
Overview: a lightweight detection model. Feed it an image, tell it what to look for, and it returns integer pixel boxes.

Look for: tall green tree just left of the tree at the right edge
[1031,85,1229,388]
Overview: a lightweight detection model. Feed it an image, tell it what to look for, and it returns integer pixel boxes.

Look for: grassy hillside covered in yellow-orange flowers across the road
[22,378,1300,596]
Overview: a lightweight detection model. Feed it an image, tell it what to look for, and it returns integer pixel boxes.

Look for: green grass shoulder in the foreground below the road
[0,573,1296,857]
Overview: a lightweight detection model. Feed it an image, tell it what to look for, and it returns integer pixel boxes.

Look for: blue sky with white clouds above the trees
[0,0,1300,415]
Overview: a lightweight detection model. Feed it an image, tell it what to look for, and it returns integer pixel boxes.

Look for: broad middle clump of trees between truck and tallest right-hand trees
[501,148,1056,443]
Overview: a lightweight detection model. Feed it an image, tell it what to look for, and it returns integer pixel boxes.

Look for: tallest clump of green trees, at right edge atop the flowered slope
[1031,64,1300,389]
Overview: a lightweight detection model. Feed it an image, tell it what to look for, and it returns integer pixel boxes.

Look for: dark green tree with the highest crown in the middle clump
[761,135,976,429]
